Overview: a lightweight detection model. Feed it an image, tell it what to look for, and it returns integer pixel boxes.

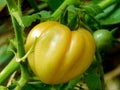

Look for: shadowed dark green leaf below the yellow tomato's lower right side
[84,58,101,90]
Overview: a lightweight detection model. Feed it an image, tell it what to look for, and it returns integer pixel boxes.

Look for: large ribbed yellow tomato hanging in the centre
[26,21,95,84]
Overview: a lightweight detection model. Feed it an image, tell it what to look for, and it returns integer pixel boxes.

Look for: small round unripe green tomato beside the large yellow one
[93,29,113,51]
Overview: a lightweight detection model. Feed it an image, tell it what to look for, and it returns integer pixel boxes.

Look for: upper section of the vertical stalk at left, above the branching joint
[6,0,25,57]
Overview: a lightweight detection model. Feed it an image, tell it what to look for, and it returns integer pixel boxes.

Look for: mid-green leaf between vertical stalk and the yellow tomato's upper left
[22,14,40,27]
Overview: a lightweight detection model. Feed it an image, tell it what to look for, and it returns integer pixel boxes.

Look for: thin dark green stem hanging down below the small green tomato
[95,50,105,90]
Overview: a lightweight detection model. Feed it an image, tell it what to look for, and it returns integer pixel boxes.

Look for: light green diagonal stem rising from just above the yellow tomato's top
[52,0,76,20]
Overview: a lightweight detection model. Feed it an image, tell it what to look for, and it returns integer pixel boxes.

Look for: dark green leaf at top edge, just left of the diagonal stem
[44,0,64,10]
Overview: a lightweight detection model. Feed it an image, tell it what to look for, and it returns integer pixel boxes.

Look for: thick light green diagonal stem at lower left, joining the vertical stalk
[0,58,19,84]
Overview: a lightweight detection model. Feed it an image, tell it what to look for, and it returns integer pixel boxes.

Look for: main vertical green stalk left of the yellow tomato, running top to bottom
[7,0,29,90]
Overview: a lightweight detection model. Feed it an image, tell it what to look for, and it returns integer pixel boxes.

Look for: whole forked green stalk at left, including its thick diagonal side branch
[0,0,28,90]
